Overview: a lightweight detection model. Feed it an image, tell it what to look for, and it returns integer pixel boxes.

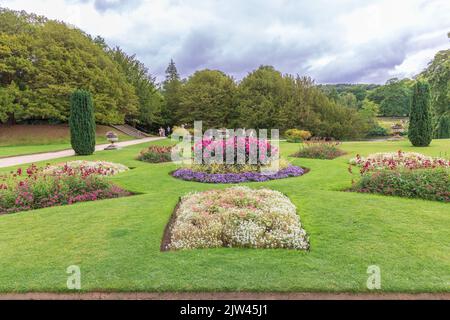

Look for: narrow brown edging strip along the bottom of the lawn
[0,292,450,300]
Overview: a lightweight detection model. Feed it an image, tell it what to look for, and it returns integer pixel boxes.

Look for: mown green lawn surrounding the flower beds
[0,140,450,292]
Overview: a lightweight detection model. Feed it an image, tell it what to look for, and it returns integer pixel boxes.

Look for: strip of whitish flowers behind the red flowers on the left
[44,160,129,176]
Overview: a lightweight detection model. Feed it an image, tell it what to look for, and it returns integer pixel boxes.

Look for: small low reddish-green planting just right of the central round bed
[293,141,346,160]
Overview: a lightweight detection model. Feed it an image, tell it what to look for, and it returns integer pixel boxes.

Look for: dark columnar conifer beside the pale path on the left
[69,90,95,155]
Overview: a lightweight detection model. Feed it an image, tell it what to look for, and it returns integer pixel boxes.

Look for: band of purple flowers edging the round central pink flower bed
[172,165,306,183]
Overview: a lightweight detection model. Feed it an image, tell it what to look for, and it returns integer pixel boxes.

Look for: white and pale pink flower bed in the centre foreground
[167,186,309,250]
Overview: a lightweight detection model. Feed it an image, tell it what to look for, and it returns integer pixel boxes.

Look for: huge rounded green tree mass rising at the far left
[0,9,138,124]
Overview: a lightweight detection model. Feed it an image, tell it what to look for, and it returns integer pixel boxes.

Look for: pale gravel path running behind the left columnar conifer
[0,137,165,168]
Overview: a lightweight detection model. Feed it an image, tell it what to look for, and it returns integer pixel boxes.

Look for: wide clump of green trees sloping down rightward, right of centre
[236,66,365,139]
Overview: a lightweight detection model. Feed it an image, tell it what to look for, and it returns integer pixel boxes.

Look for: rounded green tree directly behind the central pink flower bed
[177,69,236,128]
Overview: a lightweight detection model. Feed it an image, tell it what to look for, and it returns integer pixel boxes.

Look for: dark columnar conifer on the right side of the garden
[408,80,433,147]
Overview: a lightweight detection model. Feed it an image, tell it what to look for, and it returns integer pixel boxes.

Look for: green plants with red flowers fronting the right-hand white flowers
[352,169,450,202]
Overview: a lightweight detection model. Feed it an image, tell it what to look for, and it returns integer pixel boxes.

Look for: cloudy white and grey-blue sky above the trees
[0,0,450,83]
